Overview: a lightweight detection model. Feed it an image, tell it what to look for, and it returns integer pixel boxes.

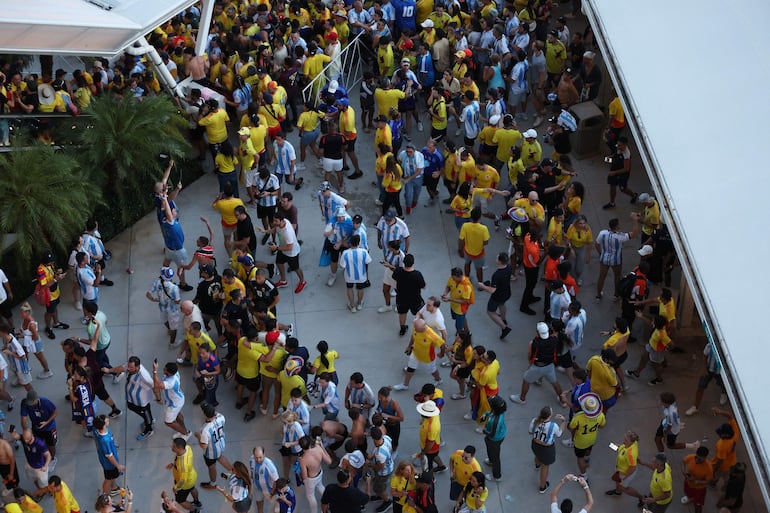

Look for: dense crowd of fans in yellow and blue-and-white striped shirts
[0,0,745,513]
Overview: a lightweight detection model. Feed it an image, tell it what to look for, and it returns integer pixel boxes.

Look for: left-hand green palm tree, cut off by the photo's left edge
[0,143,102,261]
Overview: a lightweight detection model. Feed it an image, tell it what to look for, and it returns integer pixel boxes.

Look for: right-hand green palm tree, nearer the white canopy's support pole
[79,95,189,224]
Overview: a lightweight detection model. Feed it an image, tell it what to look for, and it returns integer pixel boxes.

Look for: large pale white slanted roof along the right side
[583,0,770,504]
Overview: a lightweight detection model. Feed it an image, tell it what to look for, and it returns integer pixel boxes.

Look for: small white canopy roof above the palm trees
[0,0,195,56]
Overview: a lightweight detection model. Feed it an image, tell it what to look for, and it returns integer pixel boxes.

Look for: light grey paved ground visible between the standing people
[13,102,763,513]
